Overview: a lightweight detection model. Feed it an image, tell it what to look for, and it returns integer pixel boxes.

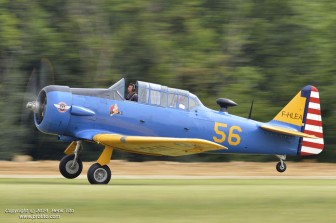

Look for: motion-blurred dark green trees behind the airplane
[0,0,336,162]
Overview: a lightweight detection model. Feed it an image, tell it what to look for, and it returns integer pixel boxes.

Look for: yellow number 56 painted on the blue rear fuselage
[212,122,242,146]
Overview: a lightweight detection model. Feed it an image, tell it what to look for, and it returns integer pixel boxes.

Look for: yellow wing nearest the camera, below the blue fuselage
[93,134,227,156]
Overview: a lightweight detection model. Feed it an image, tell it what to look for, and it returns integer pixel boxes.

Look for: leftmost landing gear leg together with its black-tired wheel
[59,141,83,179]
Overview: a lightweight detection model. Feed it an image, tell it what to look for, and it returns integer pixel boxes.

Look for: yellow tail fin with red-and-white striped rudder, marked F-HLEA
[270,86,324,156]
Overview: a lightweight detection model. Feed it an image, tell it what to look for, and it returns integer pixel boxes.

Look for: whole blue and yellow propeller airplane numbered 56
[27,79,324,184]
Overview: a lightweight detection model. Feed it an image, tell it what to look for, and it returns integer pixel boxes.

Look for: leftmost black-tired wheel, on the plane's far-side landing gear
[59,154,83,179]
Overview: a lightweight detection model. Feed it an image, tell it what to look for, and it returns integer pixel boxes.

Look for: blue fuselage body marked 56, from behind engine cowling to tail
[63,94,299,155]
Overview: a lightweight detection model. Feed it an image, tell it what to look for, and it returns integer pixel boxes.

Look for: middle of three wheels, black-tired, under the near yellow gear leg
[87,163,111,184]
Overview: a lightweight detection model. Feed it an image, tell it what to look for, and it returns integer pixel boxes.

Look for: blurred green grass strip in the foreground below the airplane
[0,179,336,223]
